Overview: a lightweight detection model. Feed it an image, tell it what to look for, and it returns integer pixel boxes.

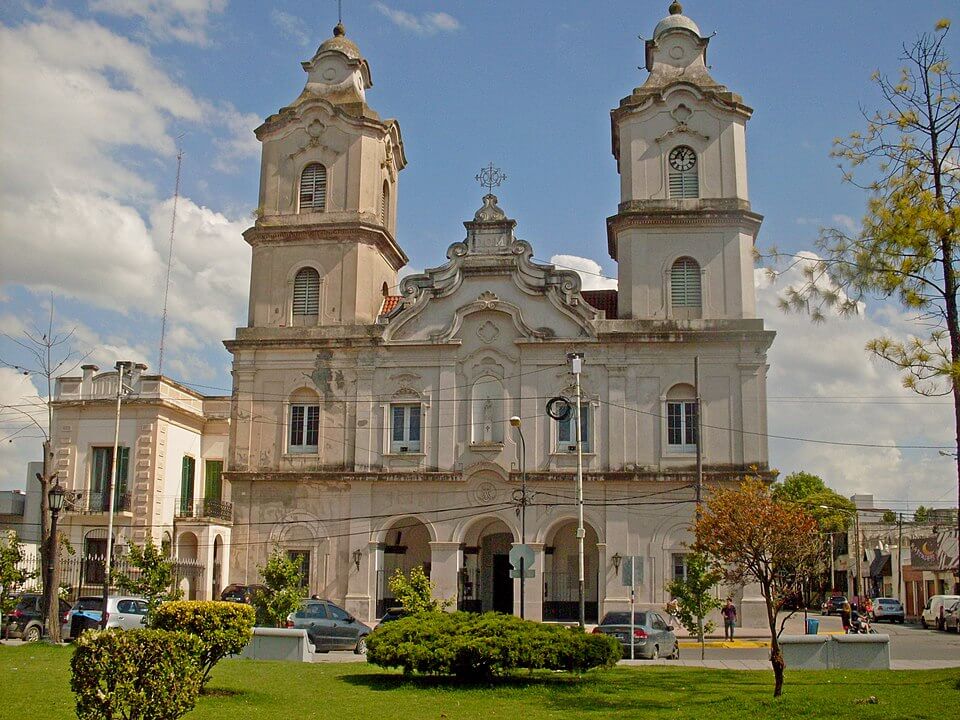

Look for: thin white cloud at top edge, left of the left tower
[90,0,227,45]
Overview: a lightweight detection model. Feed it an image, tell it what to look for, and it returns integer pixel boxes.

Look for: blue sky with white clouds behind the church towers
[0,0,960,510]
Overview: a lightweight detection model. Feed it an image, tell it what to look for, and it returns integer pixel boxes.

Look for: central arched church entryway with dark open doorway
[457,518,514,614]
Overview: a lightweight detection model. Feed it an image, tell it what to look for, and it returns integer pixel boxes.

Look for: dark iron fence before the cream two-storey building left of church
[19,554,206,602]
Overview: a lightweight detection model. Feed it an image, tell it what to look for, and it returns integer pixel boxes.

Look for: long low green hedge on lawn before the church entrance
[367,612,620,678]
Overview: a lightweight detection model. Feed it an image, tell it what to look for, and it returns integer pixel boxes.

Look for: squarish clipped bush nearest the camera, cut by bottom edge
[70,630,201,720]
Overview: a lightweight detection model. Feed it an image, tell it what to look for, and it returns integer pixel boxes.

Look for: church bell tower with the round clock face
[607,2,762,321]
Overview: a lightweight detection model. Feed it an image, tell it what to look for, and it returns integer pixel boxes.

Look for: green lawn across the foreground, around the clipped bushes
[0,645,960,720]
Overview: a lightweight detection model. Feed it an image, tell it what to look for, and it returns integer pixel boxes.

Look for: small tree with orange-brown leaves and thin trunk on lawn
[693,479,824,697]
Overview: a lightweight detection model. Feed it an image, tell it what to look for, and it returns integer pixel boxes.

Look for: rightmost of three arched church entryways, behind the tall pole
[543,520,600,622]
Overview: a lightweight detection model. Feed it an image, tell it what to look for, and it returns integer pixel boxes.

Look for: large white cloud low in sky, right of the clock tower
[755,254,956,505]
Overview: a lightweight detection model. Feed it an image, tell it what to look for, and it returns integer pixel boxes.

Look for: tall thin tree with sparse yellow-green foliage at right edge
[774,20,960,592]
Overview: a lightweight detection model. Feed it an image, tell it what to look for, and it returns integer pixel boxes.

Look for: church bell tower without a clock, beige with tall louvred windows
[244,24,407,332]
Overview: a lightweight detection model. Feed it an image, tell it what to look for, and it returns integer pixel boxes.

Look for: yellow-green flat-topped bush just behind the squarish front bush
[150,600,255,686]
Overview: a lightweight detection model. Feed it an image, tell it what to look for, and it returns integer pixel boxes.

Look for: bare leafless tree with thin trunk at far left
[0,298,89,643]
